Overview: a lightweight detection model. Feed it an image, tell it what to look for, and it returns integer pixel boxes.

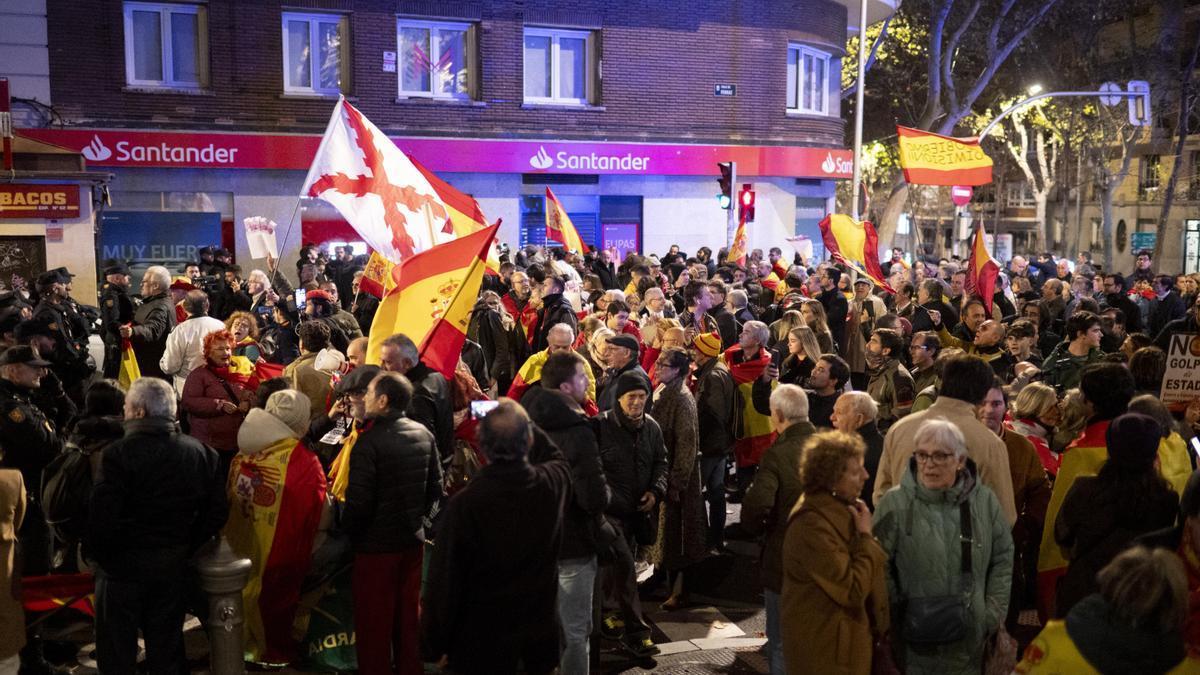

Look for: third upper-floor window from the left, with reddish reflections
[396,19,473,98]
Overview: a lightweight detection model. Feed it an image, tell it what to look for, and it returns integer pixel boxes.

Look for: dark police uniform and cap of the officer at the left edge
[0,346,61,575]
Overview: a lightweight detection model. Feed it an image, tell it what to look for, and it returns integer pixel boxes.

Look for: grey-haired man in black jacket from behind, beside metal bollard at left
[88,377,229,673]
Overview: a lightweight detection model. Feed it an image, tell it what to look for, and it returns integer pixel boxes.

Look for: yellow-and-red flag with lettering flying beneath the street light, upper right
[896,126,991,185]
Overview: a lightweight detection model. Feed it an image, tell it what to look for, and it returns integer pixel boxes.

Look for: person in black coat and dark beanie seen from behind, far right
[1046,413,1180,619]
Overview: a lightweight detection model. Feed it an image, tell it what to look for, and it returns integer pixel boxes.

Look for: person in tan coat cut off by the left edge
[0,470,25,673]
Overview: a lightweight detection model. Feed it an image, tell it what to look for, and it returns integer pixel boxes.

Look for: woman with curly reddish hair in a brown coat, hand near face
[780,431,888,675]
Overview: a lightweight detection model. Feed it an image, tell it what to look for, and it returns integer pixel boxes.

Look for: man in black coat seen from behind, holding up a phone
[421,399,571,675]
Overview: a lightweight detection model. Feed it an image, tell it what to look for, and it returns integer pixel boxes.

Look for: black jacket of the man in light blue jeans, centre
[521,387,614,560]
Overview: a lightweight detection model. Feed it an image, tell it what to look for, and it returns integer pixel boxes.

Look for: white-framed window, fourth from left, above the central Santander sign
[524,28,595,106]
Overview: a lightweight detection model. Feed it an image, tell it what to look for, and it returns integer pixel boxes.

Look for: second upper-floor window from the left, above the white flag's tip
[283,12,349,94]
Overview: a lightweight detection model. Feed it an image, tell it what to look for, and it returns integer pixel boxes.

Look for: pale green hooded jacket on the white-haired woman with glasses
[875,454,1013,674]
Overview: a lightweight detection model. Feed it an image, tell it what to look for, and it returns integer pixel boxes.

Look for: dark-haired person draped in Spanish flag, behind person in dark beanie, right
[1038,363,1137,617]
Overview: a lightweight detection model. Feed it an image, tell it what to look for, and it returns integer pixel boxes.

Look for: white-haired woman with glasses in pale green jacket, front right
[875,419,1013,674]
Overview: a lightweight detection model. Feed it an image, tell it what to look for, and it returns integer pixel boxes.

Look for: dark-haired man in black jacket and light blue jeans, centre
[521,352,617,673]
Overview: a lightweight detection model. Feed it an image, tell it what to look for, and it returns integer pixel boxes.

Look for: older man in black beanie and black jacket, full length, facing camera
[596,372,667,656]
